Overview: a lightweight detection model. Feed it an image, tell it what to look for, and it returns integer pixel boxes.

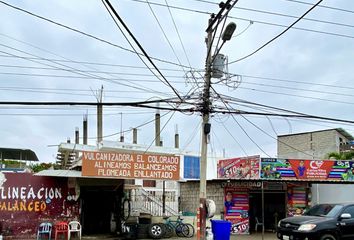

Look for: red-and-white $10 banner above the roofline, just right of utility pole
[218,156,260,179]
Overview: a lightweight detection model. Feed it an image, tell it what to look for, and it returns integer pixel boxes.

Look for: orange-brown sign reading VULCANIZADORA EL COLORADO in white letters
[82,152,180,180]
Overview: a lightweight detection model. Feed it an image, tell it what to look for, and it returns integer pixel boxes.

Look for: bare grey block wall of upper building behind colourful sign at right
[278,129,347,159]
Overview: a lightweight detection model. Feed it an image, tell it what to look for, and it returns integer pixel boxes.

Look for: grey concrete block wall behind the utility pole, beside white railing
[180,182,224,215]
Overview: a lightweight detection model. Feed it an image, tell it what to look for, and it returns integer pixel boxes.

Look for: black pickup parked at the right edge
[277,203,354,240]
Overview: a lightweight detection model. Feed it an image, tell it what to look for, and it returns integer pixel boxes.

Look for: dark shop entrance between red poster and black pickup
[249,191,286,231]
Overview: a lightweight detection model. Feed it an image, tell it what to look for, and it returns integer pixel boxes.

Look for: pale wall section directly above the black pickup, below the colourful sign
[312,184,354,204]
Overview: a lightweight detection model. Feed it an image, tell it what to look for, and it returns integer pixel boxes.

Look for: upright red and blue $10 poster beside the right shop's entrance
[224,187,249,234]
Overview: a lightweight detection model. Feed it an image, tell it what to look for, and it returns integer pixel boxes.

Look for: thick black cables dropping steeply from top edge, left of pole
[102,0,183,101]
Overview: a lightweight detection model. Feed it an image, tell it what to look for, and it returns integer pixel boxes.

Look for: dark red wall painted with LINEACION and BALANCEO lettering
[0,172,79,236]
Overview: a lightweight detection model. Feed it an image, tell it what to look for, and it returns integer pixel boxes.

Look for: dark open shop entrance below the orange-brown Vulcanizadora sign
[81,186,123,235]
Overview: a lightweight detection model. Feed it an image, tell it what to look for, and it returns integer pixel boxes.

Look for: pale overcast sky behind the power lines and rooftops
[0,0,354,162]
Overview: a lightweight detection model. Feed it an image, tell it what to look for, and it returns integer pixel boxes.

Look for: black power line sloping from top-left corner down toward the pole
[0,0,188,68]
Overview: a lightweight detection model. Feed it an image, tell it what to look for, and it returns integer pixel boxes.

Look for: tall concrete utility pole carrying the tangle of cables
[198,15,214,240]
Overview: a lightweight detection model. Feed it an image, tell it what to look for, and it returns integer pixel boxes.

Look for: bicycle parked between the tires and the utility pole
[164,216,194,238]
